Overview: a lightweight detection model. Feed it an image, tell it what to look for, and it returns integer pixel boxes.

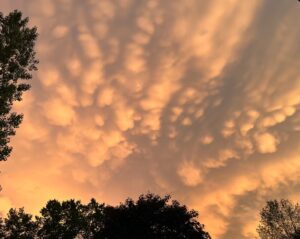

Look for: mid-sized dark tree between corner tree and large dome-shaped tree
[37,199,104,239]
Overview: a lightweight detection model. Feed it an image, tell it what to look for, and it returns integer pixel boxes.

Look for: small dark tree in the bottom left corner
[0,208,38,239]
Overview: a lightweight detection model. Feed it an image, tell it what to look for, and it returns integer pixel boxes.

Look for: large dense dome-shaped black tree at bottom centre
[103,193,210,239]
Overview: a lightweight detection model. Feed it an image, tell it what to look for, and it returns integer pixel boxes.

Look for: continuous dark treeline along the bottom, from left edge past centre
[0,194,210,239]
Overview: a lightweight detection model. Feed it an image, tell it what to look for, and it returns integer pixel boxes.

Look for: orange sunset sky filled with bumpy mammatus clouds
[0,0,300,239]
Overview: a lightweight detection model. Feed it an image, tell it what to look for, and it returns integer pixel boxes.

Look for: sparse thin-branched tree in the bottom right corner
[257,199,300,239]
